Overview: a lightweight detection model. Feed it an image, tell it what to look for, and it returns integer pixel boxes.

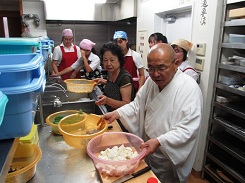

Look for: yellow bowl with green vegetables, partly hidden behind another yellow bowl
[46,110,83,135]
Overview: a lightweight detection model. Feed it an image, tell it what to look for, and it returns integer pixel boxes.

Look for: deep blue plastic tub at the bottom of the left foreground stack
[0,70,46,140]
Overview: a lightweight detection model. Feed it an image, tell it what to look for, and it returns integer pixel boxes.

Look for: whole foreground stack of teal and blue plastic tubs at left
[0,38,46,140]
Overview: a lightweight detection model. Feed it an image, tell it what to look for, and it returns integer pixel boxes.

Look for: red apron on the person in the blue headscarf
[124,56,139,92]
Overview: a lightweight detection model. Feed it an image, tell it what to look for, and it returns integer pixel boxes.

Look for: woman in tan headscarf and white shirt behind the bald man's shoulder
[171,39,199,81]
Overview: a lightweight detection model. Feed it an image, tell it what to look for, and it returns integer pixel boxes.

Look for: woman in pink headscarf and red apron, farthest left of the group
[52,29,81,80]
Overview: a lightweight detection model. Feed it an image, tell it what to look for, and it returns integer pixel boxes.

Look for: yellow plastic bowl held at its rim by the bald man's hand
[58,114,108,150]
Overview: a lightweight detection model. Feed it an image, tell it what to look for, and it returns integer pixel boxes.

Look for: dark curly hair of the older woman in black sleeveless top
[100,41,124,68]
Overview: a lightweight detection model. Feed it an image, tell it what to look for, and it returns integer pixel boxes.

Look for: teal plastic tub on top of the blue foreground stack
[0,38,42,55]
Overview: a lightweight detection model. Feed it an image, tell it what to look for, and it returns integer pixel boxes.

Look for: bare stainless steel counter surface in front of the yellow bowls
[29,125,101,183]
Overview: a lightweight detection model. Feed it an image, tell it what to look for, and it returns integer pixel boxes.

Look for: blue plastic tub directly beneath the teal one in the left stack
[0,53,43,87]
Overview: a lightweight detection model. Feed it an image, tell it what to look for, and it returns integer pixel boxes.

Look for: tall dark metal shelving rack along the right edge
[203,0,245,183]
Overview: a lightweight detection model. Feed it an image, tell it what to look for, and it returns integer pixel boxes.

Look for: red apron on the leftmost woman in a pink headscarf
[58,45,81,80]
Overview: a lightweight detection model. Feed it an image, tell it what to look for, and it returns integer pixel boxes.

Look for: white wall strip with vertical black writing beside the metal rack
[192,0,223,171]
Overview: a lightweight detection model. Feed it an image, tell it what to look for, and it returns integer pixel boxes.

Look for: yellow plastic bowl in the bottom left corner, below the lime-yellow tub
[5,144,42,183]
